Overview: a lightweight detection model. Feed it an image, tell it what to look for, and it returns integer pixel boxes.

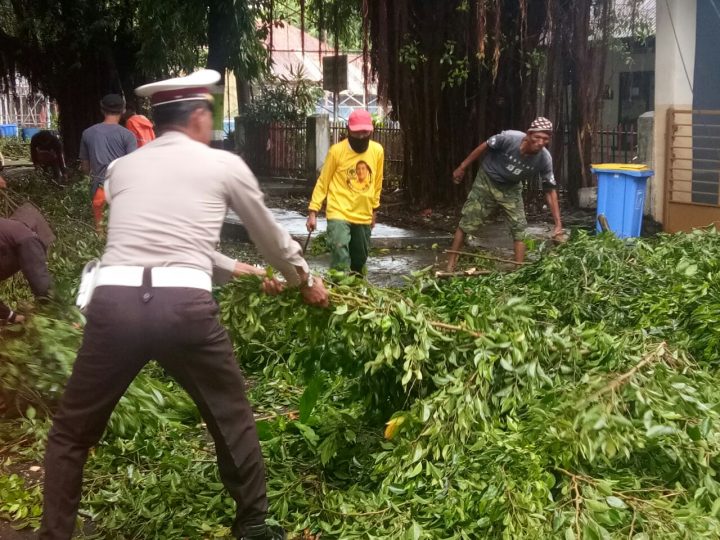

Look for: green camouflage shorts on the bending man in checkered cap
[460,168,527,240]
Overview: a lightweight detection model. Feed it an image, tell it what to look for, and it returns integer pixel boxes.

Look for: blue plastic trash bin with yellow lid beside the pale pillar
[592,164,654,238]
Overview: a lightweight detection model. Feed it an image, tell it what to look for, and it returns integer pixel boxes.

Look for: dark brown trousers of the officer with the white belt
[40,280,267,540]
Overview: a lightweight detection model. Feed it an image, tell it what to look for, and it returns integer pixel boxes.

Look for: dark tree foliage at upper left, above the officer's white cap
[0,0,270,158]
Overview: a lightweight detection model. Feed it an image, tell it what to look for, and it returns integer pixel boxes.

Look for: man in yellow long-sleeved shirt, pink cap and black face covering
[307,109,385,273]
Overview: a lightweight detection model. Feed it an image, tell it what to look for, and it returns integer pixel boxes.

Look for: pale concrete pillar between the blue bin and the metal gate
[648,0,697,223]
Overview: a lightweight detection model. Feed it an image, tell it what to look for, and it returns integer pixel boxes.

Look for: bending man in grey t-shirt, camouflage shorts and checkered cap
[447,117,563,272]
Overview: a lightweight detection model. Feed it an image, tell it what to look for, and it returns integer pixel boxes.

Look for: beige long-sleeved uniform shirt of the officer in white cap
[101,131,308,284]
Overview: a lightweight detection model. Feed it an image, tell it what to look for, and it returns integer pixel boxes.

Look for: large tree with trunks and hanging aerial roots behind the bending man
[281,0,648,205]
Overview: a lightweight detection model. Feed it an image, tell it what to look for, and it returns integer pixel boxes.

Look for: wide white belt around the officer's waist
[95,266,212,292]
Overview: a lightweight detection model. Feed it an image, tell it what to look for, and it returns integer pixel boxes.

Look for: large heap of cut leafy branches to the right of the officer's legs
[222,231,720,539]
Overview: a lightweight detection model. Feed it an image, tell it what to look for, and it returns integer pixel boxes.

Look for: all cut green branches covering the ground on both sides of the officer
[0,172,720,540]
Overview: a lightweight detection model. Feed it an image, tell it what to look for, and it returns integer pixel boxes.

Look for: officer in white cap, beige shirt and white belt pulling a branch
[40,70,328,540]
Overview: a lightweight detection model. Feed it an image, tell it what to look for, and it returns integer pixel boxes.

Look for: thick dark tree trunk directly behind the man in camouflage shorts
[369,0,545,207]
